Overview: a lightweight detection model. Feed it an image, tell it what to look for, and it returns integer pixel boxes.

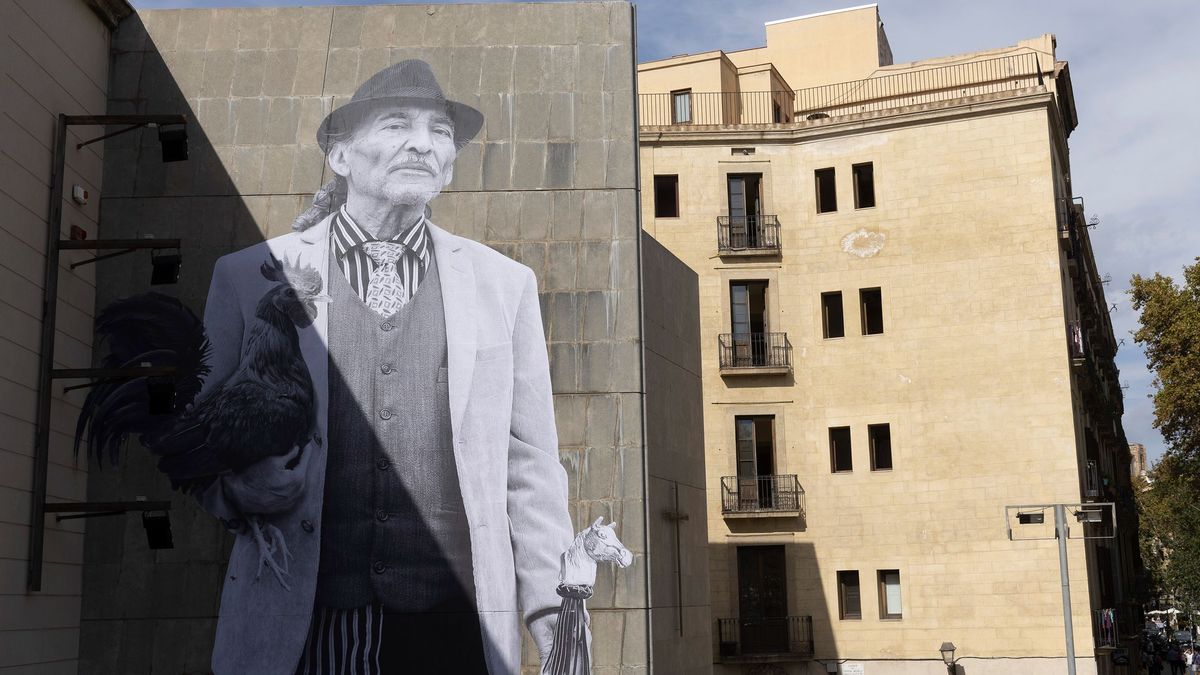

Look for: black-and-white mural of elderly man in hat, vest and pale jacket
[202,60,574,675]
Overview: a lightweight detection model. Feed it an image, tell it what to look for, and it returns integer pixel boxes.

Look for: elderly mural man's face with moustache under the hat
[329,103,458,205]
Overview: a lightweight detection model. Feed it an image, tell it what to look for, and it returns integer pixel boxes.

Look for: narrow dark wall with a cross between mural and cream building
[642,233,713,675]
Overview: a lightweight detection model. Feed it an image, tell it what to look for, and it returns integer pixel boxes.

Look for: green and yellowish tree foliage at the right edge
[1129,258,1200,609]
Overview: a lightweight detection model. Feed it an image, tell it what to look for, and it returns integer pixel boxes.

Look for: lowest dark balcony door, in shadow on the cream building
[738,546,788,653]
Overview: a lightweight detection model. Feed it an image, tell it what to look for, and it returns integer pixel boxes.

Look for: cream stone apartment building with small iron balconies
[637,5,1141,675]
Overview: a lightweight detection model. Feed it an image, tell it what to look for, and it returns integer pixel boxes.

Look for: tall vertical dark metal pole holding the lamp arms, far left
[26,114,67,591]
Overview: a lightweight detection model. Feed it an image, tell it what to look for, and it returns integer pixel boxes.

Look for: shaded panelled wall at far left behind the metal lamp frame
[0,0,125,674]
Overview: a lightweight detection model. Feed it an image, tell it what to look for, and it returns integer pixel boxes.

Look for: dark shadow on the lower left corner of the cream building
[709,538,840,675]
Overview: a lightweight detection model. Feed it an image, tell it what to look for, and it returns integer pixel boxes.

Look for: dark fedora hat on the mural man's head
[317,59,484,153]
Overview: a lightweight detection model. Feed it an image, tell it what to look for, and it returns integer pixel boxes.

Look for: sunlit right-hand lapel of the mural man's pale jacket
[428,222,478,441]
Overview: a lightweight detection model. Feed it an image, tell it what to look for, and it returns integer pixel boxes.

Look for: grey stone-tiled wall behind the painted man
[82,2,662,674]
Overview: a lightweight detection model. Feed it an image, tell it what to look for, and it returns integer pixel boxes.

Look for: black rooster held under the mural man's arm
[74,256,322,589]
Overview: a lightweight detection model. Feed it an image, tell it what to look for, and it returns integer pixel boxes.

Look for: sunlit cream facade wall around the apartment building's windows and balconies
[641,88,1094,674]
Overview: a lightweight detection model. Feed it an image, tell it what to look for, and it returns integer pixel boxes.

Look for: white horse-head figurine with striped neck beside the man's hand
[541,515,634,675]
